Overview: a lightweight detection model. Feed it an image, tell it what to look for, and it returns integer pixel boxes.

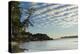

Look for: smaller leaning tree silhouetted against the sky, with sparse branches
[22,8,36,32]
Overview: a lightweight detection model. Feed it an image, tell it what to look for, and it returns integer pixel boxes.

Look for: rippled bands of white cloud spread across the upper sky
[22,3,78,28]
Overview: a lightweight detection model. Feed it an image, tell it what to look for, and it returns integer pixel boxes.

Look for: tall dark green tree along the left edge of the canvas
[10,1,22,36]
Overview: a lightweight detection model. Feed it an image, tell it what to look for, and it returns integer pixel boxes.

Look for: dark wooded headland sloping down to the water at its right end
[12,32,53,42]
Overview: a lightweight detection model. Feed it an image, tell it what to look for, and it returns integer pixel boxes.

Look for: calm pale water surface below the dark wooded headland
[20,38,78,52]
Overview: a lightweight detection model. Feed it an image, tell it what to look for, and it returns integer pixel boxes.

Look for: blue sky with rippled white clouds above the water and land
[20,2,78,38]
